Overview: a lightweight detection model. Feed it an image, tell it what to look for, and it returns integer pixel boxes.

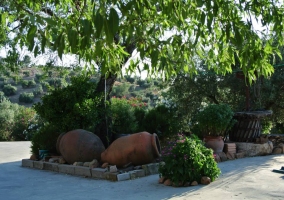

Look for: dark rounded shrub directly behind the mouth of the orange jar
[143,105,180,138]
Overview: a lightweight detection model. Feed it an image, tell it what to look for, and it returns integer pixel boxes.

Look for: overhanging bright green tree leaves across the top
[0,0,284,81]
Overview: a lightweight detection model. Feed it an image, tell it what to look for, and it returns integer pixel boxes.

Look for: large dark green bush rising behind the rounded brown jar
[34,76,105,132]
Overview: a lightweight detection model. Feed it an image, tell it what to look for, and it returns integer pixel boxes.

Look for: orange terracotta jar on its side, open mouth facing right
[101,132,161,167]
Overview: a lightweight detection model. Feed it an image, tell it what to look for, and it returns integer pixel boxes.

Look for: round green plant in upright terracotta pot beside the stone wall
[193,104,235,153]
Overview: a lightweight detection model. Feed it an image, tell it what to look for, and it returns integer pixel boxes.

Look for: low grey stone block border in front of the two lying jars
[22,159,160,181]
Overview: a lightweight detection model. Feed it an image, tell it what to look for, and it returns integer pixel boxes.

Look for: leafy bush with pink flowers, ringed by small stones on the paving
[159,134,221,185]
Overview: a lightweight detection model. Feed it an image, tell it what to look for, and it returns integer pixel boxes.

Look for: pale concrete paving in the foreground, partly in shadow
[0,142,284,200]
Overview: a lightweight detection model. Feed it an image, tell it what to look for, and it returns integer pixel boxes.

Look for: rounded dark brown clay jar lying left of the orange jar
[56,129,105,164]
